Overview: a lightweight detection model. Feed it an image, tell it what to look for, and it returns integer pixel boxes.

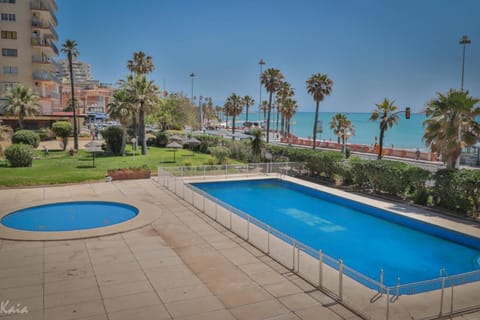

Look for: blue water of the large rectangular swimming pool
[193,179,480,286]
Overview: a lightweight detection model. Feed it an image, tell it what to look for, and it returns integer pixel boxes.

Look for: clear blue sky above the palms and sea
[57,0,480,112]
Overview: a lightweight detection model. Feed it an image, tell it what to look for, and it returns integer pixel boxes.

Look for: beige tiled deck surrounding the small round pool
[0,180,480,320]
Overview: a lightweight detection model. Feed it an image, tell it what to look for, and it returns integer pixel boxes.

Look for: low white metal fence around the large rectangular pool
[157,163,480,320]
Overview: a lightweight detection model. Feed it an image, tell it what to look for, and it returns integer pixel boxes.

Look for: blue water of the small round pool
[1,201,138,232]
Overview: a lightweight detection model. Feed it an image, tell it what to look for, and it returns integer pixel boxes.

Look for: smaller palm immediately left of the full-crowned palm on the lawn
[107,89,135,155]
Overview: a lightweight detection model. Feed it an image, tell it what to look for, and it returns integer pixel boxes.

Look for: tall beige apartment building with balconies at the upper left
[0,0,60,114]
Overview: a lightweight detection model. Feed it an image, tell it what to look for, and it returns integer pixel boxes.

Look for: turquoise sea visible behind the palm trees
[234,112,429,151]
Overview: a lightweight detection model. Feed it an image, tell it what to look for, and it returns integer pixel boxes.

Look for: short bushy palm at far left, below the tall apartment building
[4,85,40,129]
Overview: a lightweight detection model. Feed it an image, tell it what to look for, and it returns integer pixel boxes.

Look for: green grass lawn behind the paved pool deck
[0,147,235,187]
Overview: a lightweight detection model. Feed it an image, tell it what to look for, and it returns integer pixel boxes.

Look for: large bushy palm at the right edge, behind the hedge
[423,89,480,168]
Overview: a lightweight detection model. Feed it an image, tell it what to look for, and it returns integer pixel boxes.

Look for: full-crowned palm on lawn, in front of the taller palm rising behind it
[119,75,160,155]
